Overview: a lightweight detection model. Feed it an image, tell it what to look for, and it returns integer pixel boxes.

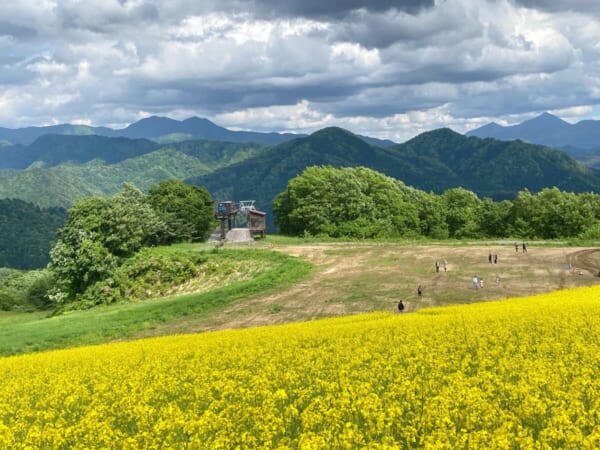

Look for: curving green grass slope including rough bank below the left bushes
[0,245,310,355]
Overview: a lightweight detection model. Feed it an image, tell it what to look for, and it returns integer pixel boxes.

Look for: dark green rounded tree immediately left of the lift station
[148,180,215,244]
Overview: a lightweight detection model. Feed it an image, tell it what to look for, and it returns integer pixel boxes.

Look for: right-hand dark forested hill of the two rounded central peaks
[386,129,600,200]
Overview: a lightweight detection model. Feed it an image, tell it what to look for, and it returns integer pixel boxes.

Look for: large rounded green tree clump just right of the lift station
[273,166,419,238]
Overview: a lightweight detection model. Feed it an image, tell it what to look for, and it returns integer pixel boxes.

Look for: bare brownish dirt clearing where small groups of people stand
[139,244,600,336]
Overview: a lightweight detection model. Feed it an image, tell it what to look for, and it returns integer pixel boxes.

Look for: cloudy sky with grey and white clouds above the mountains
[0,0,600,142]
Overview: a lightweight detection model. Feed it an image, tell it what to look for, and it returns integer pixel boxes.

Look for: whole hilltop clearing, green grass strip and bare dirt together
[0,243,600,355]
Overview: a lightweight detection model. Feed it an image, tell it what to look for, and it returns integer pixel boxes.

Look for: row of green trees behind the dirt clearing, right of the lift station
[273,166,600,239]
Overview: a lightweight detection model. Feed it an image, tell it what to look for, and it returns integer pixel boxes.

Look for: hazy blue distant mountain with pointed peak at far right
[466,113,600,159]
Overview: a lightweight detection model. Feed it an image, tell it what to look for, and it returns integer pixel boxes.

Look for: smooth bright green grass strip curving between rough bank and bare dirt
[0,249,312,356]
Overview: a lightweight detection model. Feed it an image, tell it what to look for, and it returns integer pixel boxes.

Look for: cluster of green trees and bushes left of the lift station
[49,180,214,304]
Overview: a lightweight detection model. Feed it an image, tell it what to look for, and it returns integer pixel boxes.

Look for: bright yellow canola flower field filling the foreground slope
[0,286,600,449]
